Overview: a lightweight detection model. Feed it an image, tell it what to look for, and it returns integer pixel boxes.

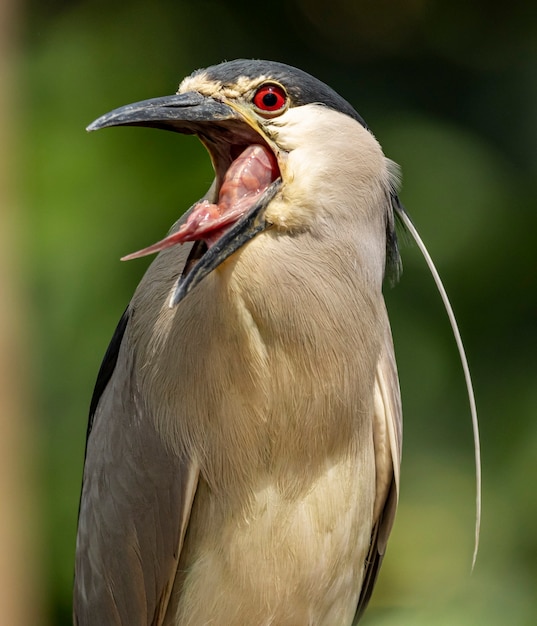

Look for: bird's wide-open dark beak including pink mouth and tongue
[87,92,282,307]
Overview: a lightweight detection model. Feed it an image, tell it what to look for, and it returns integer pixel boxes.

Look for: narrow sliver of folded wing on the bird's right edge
[353,312,403,624]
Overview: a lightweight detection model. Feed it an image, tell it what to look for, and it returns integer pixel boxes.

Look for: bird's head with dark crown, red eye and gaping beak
[88,60,397,306]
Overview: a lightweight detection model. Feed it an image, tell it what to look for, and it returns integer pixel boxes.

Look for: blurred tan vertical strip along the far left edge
[0,0,43,626]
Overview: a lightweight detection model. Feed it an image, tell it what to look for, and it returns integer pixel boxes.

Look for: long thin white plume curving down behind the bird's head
[394,198,481,570]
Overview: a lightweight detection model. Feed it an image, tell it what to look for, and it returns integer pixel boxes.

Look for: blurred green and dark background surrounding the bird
[0,0,537,626]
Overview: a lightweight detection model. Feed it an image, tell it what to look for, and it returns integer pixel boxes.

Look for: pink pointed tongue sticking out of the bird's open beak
[122,144,280,261]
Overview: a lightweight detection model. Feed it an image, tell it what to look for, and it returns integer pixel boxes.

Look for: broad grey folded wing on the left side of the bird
[73,304,198,626]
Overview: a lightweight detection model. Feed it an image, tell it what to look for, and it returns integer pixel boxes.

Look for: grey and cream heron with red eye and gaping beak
[73,59,402,626]
